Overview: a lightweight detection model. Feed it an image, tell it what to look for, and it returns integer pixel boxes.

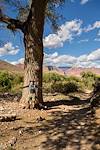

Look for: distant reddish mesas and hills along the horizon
[0,60,100,76]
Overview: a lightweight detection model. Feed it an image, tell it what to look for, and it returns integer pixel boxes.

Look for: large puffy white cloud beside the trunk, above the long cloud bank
[43,20,82,48]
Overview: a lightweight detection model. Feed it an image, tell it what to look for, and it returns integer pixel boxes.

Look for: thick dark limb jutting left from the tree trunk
[0,13,24,32]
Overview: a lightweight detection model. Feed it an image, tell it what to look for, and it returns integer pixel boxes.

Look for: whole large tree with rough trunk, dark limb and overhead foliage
[0,0,63,108]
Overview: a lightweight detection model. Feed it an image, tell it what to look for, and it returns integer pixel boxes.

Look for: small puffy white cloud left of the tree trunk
[0,42,19,56]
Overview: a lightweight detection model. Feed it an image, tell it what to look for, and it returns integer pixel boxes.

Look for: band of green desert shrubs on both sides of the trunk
[0,71,100,94]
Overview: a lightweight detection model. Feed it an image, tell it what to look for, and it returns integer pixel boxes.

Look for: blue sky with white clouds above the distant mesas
[0,0,100,68]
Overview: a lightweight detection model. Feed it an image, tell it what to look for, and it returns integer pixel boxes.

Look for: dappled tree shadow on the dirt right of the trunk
[34,96,100,150]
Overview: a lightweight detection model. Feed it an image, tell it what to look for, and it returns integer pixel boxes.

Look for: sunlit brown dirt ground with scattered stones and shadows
[0,93,100,150]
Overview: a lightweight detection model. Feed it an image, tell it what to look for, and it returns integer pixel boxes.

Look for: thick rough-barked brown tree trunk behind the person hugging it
[21,0,47,106]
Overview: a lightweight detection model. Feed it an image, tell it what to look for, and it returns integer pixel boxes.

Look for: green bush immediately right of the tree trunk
[43,73,80,94]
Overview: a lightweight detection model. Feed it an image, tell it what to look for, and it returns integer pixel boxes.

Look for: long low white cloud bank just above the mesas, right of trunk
[44,49,100,68]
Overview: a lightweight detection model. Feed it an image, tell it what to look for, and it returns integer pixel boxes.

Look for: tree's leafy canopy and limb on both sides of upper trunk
[0,0,64,32]
